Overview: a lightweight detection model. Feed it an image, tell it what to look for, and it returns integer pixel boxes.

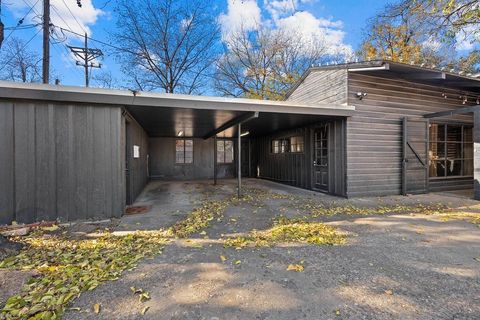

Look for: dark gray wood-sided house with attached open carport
[0,61,480,223]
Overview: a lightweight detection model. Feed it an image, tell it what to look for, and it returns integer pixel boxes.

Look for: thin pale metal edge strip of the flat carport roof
[0,81,355,116]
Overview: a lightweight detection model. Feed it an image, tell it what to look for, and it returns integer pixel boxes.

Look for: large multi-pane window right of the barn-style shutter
[429,123,473,178]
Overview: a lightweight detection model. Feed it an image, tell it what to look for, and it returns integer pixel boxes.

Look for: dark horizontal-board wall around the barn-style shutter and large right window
[347,72,473,197]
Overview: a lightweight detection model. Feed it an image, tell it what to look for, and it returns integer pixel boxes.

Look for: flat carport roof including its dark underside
[0,81,355,137]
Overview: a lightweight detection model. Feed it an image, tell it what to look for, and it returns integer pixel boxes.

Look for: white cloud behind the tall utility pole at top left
[10,0,103,35]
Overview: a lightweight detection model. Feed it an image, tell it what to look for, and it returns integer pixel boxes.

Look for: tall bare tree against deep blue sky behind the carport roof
[114,0,219,94]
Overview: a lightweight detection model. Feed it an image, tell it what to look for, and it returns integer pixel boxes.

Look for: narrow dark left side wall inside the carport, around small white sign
[125,113,149,203]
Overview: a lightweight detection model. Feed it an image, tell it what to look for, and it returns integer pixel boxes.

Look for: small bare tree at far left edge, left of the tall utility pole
[0,37,42,82]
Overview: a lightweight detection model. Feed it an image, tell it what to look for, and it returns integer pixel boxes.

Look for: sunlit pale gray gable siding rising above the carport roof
[287,69,347,104]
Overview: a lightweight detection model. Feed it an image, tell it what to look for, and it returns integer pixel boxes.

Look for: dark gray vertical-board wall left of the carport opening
[0,100,124,224]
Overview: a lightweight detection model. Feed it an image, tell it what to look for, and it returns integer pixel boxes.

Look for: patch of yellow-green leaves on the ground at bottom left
[0,231,165,319]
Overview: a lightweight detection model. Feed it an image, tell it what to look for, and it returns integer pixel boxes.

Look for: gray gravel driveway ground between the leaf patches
[54,180,480,320]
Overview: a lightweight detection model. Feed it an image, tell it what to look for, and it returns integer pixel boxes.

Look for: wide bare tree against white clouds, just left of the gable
[215,24,327,100]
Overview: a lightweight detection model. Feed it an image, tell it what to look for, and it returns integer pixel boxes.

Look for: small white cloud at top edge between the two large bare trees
[218,0,261,39]
